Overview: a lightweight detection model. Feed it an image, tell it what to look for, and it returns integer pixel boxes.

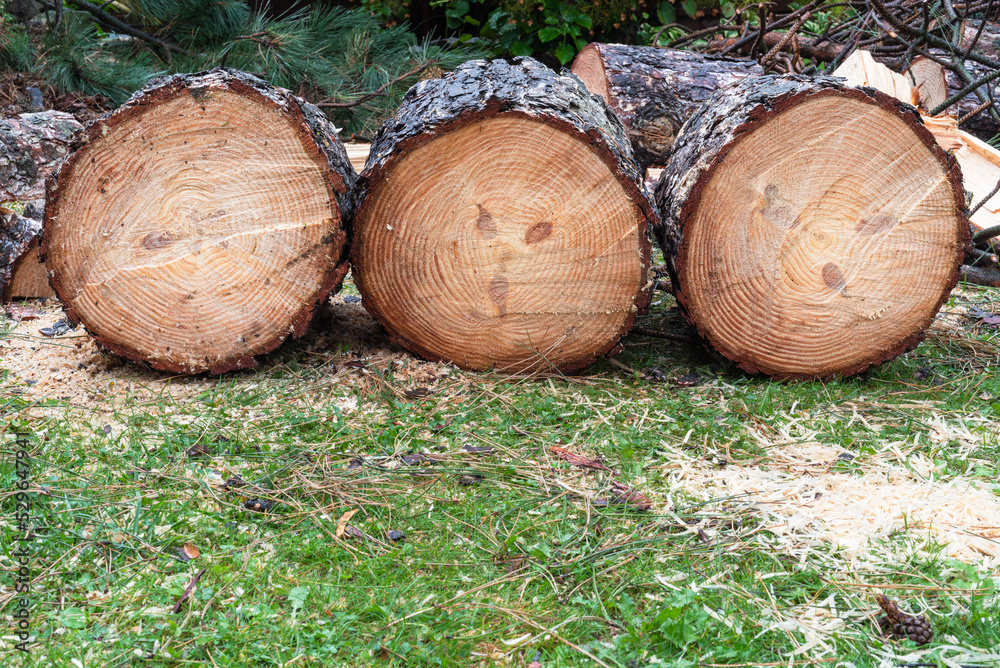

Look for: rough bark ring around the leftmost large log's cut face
[39,68,357,375]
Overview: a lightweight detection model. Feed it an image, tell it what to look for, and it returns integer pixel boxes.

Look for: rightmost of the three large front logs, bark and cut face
[655,76,969,378]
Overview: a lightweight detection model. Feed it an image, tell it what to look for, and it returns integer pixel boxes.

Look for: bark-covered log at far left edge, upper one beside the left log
[0,111,83,203]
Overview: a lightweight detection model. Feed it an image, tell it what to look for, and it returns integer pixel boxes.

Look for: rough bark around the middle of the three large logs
[351,58,658,374]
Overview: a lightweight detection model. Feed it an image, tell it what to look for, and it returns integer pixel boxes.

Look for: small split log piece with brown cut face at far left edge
[0,207,54,304]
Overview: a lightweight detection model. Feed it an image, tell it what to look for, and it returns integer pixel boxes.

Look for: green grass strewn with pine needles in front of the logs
[0,280,1000,668]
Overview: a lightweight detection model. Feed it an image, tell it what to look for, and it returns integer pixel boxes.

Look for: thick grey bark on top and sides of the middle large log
[352,58,656,372]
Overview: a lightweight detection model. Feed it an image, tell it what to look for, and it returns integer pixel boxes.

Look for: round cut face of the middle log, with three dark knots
[355,117,647,372]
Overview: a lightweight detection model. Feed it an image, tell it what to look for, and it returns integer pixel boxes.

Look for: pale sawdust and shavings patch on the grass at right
[667,442,1000,561]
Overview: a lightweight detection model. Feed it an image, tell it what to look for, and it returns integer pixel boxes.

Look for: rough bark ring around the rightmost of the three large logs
[654,75,971,380]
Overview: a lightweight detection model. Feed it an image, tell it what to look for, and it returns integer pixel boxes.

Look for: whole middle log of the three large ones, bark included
[351,58,655,373]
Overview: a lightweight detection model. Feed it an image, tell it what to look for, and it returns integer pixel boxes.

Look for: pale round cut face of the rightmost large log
[682,96,957,375]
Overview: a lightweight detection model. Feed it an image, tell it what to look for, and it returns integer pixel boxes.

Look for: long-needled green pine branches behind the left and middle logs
[0,0,480,135]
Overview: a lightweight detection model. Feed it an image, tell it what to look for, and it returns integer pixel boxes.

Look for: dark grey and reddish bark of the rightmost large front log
[653,75,968,378]
